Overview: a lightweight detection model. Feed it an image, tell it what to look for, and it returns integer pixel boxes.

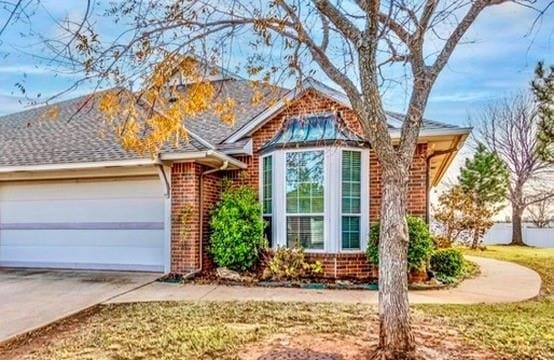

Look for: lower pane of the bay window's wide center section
[287,216,323,249]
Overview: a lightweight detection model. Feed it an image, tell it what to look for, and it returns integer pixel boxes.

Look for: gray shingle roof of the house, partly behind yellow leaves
[0,79,457,167]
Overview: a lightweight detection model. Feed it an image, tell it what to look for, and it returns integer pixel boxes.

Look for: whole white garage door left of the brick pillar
[0,178,164,271]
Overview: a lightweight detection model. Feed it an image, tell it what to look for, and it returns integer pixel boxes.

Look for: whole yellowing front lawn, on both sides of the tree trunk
[0,247,554,360]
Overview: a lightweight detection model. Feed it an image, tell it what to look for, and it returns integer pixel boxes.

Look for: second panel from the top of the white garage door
[0,198,164,223]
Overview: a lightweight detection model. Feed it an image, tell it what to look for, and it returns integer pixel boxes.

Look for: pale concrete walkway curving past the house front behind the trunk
[108,257,541,304]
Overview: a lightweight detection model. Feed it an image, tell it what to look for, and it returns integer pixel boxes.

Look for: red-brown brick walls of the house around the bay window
[171,91,427,278]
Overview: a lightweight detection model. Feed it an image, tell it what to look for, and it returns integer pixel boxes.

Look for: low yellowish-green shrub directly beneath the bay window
[264,243,323,280]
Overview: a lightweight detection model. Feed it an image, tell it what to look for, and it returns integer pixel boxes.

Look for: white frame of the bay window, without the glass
[258,146,370,253]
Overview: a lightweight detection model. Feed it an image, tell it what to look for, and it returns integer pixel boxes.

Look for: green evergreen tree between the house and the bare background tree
[458,144,509,248]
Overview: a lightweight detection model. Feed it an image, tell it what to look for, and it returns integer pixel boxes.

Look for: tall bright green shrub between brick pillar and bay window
[210,186,265,271]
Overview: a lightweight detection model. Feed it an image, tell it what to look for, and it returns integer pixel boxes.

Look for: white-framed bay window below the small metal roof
[260,146,369,253]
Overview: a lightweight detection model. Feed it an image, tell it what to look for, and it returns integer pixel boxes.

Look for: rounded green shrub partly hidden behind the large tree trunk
[367,216,433,270]
